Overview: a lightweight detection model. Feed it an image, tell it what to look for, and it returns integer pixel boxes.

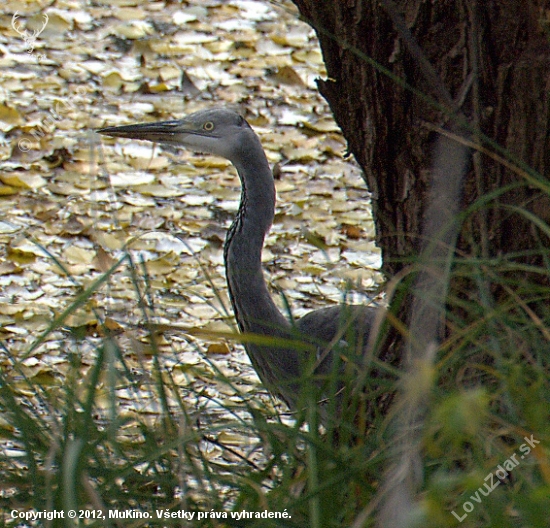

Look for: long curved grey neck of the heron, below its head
[224,140,290,336]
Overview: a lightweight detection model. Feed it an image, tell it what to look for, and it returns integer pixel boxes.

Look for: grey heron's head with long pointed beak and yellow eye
[97,108,254,161]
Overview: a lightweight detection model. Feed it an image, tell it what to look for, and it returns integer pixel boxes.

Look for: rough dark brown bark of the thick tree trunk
[294,0,550,288]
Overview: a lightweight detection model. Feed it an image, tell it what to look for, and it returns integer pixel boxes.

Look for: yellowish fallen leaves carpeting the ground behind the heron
[0,0,381,482]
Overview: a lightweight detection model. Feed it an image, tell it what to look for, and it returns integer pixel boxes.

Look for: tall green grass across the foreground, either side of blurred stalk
[0,198,550,528]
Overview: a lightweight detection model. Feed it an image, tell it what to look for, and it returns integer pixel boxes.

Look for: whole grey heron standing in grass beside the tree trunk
[98,108,375,409]
